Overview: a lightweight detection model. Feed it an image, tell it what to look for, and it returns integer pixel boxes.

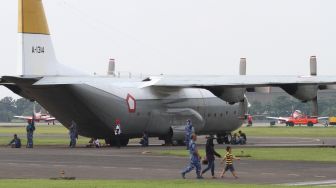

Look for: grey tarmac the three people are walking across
[0,146,336,184]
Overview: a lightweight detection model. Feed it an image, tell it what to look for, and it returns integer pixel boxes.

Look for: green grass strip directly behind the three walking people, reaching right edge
[156,148,336,162]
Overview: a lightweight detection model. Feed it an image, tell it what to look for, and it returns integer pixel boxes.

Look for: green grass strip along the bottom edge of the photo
[0,180,324,188]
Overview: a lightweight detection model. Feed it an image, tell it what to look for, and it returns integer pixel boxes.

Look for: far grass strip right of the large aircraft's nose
[241,126,336,138]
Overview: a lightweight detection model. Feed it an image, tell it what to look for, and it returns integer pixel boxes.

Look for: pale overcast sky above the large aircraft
[0,0,336,97]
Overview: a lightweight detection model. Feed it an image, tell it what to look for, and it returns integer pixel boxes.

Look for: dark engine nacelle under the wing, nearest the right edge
[282,84,318,102]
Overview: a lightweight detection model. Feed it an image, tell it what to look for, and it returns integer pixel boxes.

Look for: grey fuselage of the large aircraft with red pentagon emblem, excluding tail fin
[11,77,246,139]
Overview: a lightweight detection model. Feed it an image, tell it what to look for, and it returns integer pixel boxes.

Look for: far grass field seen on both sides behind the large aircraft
[0,124,336,145]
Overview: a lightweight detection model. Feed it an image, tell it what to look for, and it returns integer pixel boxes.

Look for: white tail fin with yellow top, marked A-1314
[18,0,82,76]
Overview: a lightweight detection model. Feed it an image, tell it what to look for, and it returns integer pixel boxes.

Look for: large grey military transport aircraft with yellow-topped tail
[0,0,336,145]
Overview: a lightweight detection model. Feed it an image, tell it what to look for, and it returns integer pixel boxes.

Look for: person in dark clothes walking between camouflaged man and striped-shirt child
[202,136,221,179]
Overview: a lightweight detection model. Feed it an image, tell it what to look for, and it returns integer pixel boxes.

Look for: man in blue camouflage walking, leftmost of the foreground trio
[181,134,203,179]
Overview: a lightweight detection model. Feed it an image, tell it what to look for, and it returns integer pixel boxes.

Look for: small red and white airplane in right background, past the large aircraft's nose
[266,110,328,127]
